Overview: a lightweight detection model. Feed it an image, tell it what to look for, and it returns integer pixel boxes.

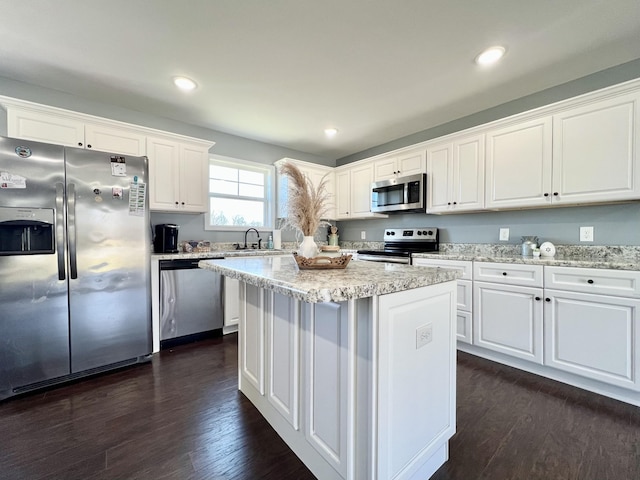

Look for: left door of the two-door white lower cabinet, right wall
[473,281,543,364]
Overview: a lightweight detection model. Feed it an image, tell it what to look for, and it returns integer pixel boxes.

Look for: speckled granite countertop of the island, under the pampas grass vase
[199,255,460,303]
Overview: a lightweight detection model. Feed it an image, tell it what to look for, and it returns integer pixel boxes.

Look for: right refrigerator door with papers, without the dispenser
[66,149,152,373]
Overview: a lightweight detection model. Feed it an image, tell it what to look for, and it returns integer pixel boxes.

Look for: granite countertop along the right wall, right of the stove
[413,246,640,270]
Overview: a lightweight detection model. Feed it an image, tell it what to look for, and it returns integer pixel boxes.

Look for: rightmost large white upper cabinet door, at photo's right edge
[553,94,640,204]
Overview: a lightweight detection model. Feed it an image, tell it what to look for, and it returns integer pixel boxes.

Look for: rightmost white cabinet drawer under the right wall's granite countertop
[544,267,640,298]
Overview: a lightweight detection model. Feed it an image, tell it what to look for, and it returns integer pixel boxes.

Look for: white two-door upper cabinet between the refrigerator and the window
[147,137,209,213]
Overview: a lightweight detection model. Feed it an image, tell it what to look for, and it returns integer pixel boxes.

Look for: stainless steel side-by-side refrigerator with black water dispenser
[0,137,152,399]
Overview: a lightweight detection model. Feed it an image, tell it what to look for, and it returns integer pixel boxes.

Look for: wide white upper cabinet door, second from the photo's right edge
[485,117,553,208]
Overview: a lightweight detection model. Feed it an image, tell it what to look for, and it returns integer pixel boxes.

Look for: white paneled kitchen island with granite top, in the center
[199,255,459,480]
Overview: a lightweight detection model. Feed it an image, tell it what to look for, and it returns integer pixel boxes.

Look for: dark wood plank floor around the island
[0,335,640,480]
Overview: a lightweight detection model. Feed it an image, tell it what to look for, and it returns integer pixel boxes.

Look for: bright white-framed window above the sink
[205,156,275,230]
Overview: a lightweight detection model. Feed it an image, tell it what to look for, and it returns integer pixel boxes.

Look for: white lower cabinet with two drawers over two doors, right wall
[458,262,640,406]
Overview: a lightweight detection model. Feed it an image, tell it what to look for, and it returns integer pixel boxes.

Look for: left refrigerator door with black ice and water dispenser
[0,137,70,399]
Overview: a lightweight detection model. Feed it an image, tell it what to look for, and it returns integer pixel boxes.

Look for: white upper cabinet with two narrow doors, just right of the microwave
[427,134,484,213]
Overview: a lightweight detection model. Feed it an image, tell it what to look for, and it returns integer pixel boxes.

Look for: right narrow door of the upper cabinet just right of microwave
[453,135,484,211]
